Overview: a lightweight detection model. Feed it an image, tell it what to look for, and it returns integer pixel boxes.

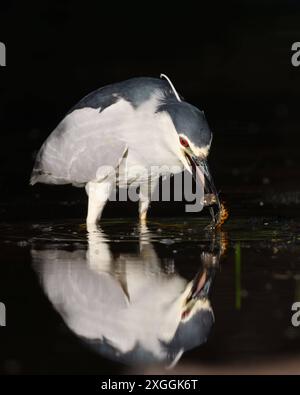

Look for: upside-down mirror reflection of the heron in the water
[32,228,218,363]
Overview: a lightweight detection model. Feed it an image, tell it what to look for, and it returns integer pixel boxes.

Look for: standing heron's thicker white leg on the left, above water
[85,181,113,224]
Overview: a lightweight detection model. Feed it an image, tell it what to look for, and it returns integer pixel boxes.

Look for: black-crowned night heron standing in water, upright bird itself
[31,75,220,223]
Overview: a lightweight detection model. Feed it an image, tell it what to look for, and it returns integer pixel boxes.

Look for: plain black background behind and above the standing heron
[0,0,300,220]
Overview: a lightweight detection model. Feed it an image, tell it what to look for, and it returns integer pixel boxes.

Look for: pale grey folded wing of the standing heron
[30,100,130,185]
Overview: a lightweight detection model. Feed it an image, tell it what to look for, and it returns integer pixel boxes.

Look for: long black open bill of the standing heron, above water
[191,156,221,225]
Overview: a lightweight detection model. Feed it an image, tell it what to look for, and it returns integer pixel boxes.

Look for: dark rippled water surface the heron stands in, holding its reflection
[0,212,300,373]
